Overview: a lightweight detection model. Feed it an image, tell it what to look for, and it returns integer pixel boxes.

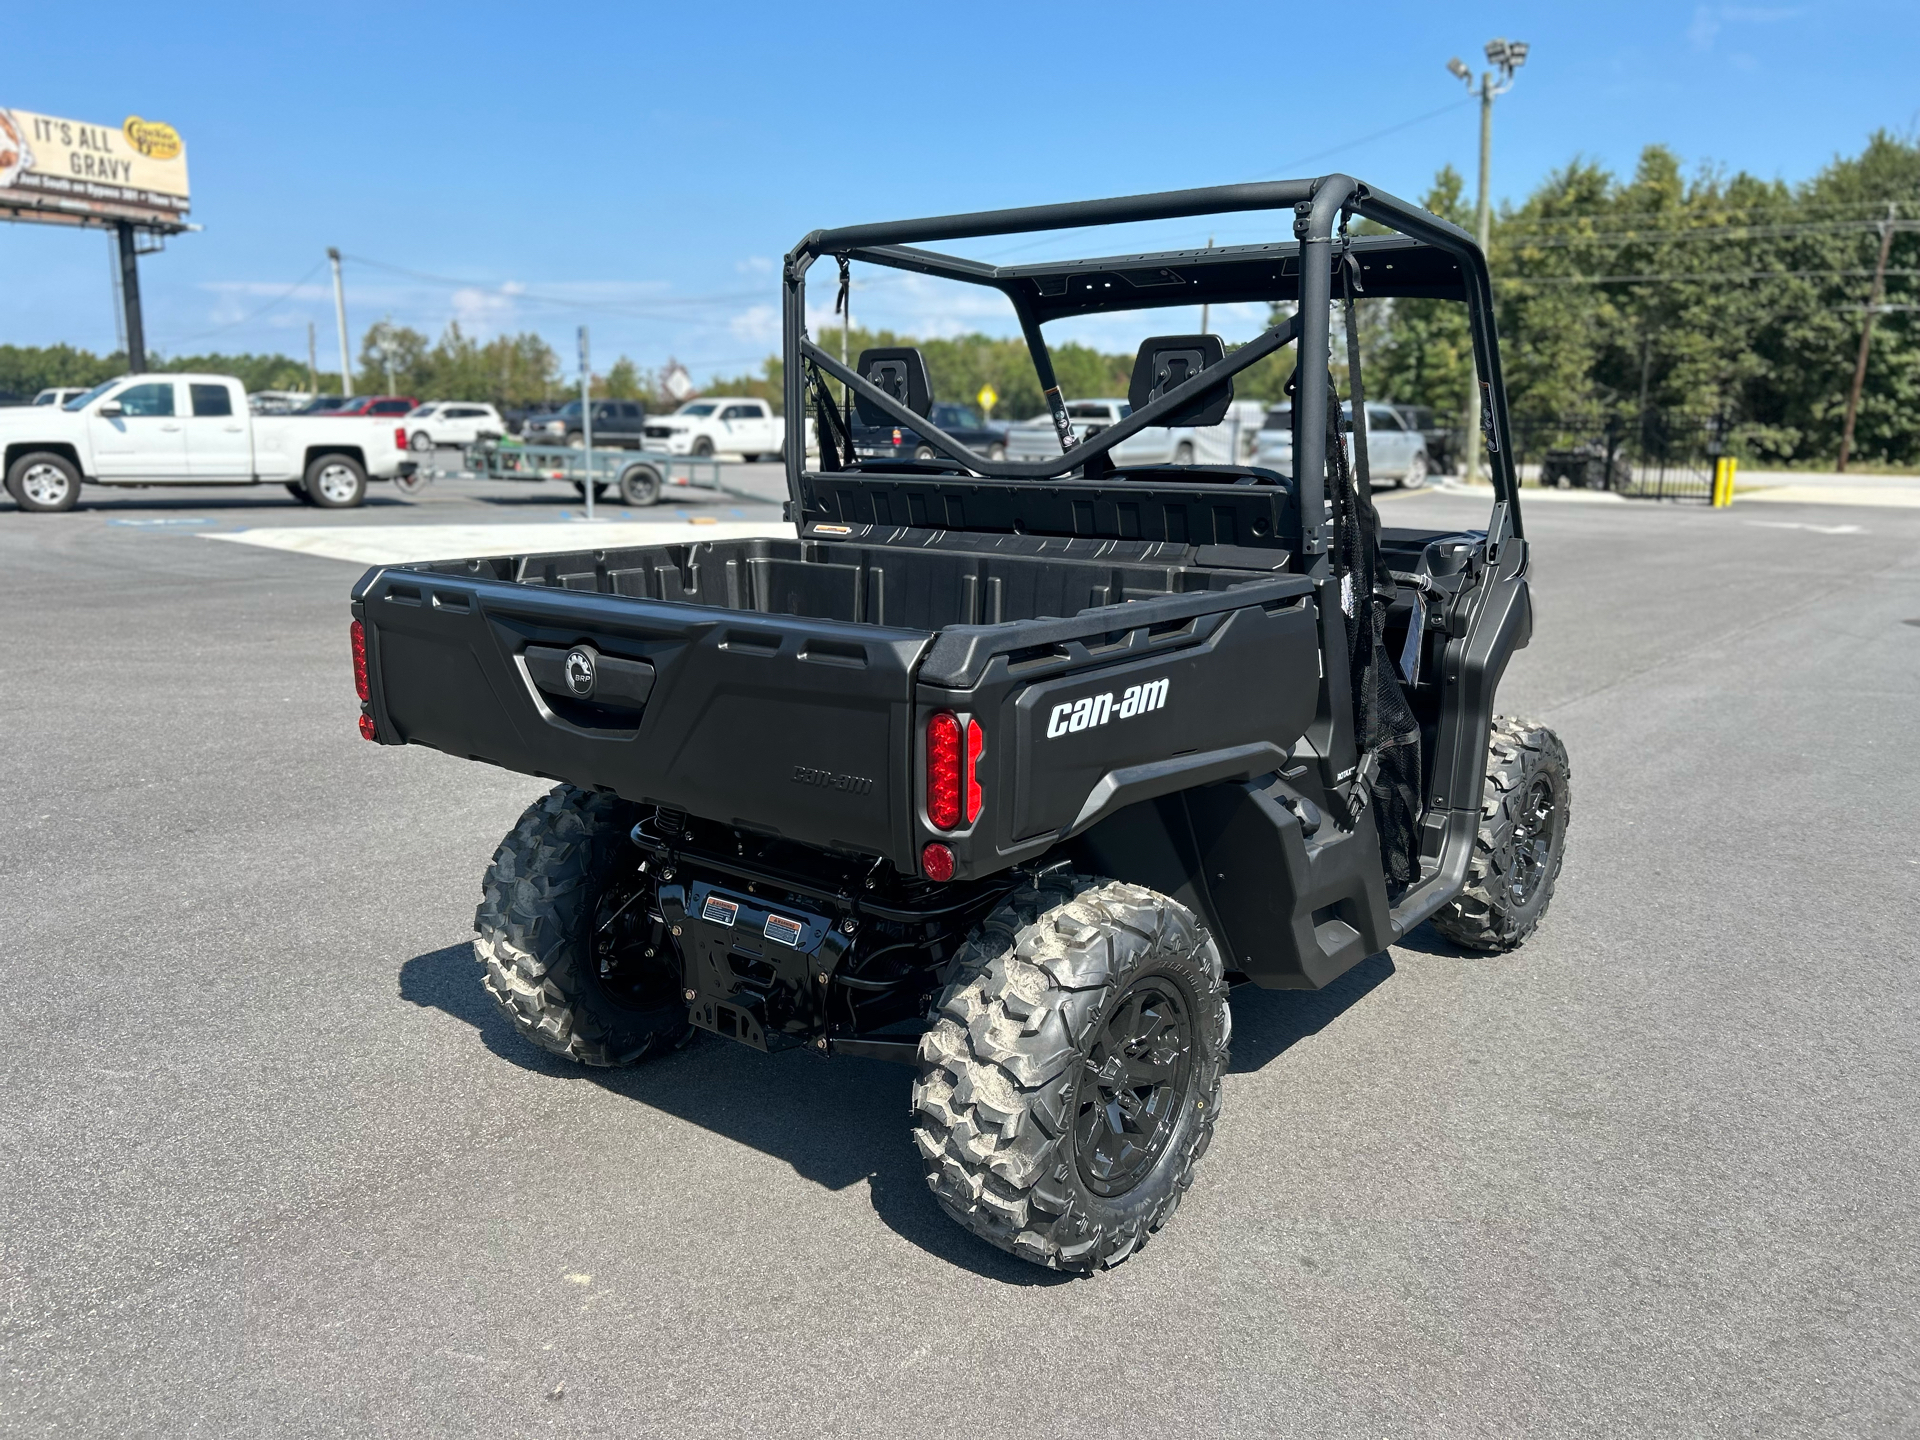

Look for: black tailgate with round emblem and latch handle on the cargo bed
[353,568,929,870]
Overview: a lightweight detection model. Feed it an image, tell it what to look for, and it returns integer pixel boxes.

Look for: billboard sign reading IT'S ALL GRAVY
[0,109,188,230]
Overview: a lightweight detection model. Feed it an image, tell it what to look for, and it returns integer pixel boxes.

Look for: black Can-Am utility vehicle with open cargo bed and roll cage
[353,175,1569,1269]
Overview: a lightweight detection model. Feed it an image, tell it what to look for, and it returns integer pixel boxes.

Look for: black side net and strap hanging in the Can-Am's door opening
[1327,265,1421,887]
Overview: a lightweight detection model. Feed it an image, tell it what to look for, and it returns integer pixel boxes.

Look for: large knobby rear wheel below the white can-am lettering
[914,876,1233,1271]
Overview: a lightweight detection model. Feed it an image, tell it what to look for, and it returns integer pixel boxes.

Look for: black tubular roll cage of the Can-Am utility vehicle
[781,175,1523,555]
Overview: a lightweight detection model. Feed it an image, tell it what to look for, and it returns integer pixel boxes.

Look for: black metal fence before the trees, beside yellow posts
[1513,411,1730,505]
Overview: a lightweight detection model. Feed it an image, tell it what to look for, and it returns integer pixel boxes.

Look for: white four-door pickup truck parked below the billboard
[0,374,417,511]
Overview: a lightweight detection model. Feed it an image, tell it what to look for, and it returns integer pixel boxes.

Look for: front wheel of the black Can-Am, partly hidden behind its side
[1434,716,1572,950]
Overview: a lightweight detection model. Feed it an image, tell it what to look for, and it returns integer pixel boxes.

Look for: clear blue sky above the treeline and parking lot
[0,0,1920,376]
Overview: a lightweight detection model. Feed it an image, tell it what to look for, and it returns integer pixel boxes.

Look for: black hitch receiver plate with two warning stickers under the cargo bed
[660,879,851,1050]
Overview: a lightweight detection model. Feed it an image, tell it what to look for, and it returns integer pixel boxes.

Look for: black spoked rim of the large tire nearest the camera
[1073,975,1192,1196]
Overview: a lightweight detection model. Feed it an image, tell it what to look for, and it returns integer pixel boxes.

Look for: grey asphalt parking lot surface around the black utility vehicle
[0,467,1920,1436]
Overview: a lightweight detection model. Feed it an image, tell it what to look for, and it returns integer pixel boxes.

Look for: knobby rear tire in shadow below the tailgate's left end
[474,785,693,1066]
